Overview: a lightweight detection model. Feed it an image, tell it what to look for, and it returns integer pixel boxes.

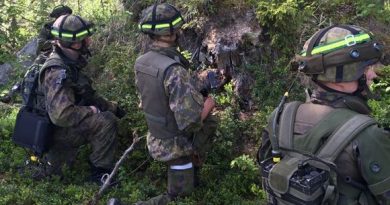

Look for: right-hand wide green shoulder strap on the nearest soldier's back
[317,114,376,162]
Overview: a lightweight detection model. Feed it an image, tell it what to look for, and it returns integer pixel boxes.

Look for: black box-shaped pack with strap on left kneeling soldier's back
[12,53,54,155]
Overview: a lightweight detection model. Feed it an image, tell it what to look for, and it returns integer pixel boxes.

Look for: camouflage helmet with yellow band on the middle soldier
[138,3,184,36]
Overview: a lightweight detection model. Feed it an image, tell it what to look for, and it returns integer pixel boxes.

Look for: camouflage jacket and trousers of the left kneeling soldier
[40,48,117,175]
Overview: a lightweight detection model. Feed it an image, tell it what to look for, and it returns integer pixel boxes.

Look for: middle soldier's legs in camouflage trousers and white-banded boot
[136,116,218,205]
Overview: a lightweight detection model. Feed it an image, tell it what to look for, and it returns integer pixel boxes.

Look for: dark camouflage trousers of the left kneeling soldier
[45,112,117,174]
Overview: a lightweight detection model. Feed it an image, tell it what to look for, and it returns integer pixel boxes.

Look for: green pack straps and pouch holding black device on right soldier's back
[260,102,376,205]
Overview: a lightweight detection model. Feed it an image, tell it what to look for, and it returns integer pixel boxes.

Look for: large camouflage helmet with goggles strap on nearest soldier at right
[292,25,383,83]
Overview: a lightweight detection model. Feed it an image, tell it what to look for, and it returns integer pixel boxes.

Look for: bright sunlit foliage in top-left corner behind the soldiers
[0,0,119,62]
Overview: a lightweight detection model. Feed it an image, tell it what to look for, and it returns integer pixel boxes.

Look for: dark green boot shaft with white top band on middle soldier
[168,161,194,197]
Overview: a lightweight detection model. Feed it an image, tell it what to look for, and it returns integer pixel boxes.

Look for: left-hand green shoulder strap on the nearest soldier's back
[278,101,302,149]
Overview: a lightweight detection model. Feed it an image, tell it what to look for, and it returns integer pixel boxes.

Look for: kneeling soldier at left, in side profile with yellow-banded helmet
[36,15,124,184]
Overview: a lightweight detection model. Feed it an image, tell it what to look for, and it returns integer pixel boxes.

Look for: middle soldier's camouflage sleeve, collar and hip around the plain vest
[143,48,216,162]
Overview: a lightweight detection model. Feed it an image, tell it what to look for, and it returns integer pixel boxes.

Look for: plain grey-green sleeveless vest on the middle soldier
[134,51,182,138]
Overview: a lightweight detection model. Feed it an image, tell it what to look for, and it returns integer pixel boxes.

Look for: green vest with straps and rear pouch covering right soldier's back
[261,102,376,205]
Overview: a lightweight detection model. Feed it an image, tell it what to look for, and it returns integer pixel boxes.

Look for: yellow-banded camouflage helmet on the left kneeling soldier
[51,15,94,43]
